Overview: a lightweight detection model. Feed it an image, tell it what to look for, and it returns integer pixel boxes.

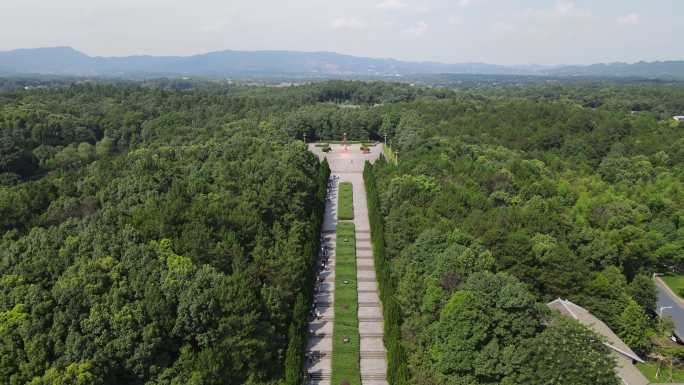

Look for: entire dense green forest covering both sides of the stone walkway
[0,80,684,385]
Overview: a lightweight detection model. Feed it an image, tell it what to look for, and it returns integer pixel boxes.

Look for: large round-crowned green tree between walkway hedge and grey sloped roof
[429,273,541,383]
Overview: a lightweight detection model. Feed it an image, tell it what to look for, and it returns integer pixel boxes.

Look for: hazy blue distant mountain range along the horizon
[0,47,684,79]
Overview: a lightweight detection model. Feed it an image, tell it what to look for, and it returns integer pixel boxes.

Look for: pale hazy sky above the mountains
[0,0,684,65]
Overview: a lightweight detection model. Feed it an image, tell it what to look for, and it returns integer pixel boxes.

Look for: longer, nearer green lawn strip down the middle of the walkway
[332,222,361,385]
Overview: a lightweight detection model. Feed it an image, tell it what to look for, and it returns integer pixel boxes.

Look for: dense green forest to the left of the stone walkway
[0,82,336,384]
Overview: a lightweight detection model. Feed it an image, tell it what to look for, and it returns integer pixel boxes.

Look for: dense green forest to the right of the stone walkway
[372,84,684,384]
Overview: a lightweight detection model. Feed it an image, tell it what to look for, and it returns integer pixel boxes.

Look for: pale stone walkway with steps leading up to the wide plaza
[307,145,387,385]
